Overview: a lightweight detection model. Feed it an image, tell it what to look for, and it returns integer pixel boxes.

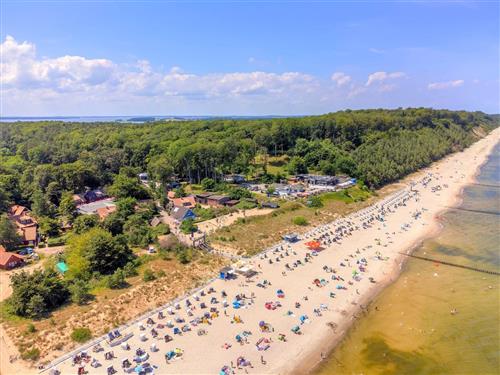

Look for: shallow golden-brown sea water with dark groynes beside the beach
[316,144,500,375]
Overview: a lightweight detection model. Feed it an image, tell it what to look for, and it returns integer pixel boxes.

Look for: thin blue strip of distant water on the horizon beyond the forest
[0,115,301,124]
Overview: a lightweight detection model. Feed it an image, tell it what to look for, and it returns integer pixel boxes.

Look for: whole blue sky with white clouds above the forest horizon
[0,0,500,116]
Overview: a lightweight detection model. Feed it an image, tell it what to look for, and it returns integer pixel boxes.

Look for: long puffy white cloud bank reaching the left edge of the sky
[1,36,317,102]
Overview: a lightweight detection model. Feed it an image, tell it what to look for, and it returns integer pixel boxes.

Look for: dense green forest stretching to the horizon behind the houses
[0,108,498,216]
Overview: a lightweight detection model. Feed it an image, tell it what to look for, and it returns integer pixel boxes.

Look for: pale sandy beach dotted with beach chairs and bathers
[9,129,500,374]
